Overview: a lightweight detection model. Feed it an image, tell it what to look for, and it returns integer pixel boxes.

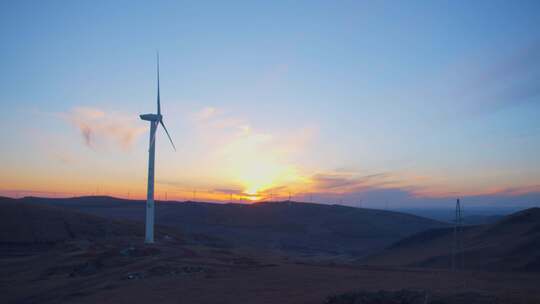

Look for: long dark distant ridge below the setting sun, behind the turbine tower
[11,197,445,256]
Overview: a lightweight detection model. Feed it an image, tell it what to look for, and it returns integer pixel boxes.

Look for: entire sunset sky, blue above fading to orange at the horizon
[0,1,540,207]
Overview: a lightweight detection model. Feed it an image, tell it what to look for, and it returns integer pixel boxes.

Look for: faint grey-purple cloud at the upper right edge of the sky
[436,41,540,115]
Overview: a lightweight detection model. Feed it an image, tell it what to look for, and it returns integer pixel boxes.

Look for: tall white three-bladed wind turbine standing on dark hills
[140,53,176,244]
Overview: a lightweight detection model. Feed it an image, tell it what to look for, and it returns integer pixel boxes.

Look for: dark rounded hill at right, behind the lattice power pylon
[362,208,540,272]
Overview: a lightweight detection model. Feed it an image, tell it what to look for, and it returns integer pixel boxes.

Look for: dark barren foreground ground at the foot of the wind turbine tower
[0,240,540,303]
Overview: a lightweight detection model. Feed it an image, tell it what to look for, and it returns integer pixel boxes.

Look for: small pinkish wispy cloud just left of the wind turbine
[61,107,146,150]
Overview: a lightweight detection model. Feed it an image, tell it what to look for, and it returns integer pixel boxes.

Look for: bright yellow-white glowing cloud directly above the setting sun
[179,106,317,194]
